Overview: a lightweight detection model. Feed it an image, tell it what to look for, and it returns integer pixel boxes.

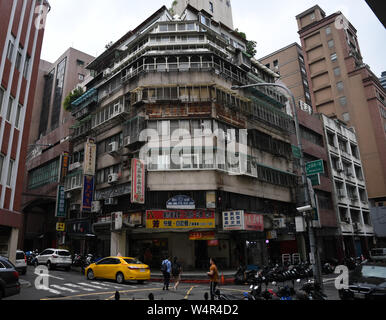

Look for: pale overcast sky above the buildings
[41,0,386,76]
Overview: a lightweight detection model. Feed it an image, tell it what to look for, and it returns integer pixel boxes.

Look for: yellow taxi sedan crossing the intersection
[85,257,150,283]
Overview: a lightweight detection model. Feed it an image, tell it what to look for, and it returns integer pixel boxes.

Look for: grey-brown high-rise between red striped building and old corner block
[21,48,94,250]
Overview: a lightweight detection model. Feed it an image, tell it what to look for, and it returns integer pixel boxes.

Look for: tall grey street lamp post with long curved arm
[231,82,323,288]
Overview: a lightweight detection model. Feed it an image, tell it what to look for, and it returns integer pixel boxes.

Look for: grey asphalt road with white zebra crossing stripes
[5,266,339,300]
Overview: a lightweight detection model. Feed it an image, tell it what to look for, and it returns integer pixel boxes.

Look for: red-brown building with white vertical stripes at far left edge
[0,0,50,261]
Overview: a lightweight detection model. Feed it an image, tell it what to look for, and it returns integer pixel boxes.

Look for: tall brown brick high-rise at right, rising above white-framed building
[296,6,386,212]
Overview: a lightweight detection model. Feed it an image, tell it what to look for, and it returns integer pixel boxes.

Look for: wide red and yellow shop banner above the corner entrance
[146,210,216,229]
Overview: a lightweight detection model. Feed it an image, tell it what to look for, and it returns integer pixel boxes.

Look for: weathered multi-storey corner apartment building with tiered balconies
[64,5,298,268]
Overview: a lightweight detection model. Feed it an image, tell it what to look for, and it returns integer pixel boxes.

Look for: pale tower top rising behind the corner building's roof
[172,0,233,29]
